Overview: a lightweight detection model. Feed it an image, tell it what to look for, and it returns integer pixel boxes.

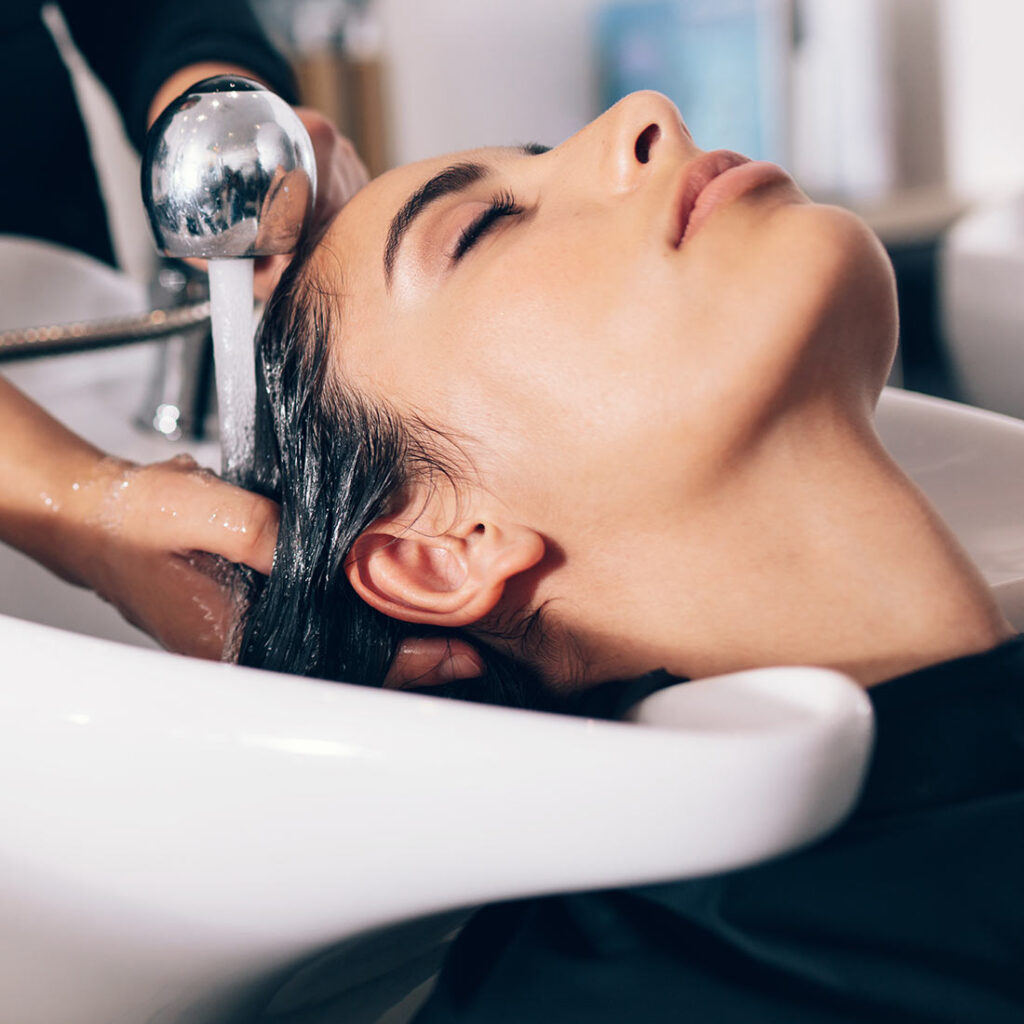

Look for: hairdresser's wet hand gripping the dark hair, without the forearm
[74,456,278,658]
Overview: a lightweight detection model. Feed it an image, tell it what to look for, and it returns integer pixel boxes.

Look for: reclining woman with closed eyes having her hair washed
[242,93,1024,1022]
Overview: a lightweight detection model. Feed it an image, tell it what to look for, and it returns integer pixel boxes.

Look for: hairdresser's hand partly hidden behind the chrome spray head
[253,106,370,299]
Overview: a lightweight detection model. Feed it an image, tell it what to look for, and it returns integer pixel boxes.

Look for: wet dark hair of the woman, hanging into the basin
[238,237,555,710]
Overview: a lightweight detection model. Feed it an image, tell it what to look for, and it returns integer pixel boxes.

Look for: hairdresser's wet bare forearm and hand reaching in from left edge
[0,378,278,657]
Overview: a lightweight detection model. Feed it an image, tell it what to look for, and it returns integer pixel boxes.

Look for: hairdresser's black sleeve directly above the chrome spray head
[60,0,296,148]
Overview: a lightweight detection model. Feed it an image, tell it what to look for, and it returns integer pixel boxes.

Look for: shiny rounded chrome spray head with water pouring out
[142,75,316,259]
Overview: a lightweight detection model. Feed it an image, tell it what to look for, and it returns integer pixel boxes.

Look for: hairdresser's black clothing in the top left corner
[0,0,295,263]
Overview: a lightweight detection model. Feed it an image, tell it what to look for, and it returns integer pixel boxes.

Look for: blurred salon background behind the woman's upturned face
[66,0,1024,416]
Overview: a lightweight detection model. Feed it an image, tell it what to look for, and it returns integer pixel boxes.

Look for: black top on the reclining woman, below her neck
[416,637,1024,1024]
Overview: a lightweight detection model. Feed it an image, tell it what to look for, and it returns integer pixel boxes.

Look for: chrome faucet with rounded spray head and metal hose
[0,75,316,438]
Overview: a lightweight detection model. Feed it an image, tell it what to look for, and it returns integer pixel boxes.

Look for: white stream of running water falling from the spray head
[209,259,256,480]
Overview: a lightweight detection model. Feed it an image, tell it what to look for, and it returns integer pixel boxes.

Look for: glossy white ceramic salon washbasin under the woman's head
[0,235,1024,1024]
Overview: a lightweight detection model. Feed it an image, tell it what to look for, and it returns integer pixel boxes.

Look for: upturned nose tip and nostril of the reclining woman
[583,92,696,193]
